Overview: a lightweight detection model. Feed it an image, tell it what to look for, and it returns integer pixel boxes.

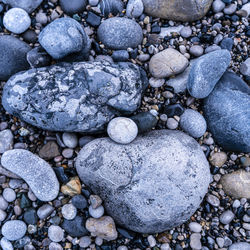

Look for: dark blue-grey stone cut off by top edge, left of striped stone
[59,0,87,15]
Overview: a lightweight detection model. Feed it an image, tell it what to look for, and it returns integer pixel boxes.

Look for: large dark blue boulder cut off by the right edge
[203,72,250,152]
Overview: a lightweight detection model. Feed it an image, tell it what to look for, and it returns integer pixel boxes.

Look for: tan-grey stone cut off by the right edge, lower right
[220,170,250,199]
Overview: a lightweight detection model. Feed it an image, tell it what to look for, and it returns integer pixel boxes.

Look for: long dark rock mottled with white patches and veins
[2,62,148,132]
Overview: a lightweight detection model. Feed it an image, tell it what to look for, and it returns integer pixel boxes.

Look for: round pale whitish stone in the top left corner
[3,8,31,34]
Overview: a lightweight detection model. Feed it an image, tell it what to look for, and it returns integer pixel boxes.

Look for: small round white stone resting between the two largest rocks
[107,117,138,144]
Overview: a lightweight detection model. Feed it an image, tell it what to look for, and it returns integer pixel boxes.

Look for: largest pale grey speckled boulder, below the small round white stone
[76,130,210,233]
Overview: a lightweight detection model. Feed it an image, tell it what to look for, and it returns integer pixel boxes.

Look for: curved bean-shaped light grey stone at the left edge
[1,149,59,201]
